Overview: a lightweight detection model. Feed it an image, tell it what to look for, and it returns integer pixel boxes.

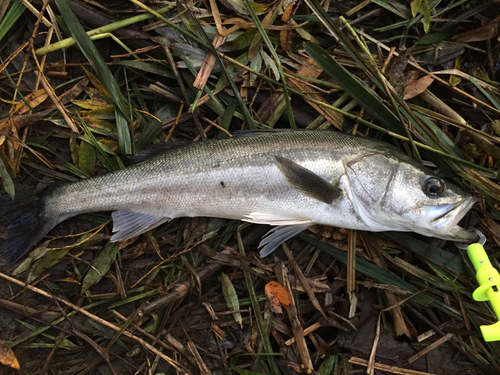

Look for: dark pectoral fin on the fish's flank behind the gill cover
[275,156,341,204]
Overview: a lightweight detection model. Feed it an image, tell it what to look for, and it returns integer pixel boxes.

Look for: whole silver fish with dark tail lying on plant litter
[0,130,477,264]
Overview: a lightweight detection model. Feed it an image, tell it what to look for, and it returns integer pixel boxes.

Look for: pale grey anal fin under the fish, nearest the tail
[111,211,170,242]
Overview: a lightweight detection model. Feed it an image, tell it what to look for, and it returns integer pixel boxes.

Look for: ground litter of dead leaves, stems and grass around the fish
[0,0,500,375]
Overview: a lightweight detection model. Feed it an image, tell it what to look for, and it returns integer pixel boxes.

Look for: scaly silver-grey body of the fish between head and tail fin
[47,132,378,223]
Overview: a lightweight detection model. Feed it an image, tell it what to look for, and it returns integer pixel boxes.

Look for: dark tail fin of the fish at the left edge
[0,191,57,264]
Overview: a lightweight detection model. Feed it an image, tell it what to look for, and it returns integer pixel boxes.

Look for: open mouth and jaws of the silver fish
[426,196,479,243]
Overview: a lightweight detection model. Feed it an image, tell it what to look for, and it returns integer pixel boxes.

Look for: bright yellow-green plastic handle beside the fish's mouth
[467,243,500,341]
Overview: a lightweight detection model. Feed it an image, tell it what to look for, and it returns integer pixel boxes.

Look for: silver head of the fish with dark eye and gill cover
[345,154,478,243]
